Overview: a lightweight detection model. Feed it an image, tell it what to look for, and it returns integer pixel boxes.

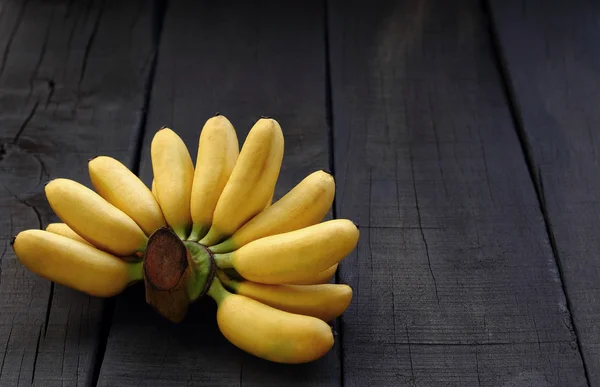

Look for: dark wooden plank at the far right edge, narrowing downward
[488,1,600,386]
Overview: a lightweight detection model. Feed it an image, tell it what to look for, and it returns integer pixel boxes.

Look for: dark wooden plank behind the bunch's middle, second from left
[99,1,340,387]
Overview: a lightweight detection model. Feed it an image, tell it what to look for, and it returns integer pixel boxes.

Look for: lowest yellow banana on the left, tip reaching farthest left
[13,230,142,297]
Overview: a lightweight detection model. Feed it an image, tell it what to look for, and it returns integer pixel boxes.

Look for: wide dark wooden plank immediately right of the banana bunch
[328,0,586,386]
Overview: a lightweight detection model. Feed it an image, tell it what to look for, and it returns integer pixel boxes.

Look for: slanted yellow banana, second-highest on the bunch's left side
[45,178,148,256]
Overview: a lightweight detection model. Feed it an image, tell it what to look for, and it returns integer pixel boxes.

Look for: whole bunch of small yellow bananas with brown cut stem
[13,115,359,363]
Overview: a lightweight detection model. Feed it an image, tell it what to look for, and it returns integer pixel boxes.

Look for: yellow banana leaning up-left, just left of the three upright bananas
[88,156,166,235]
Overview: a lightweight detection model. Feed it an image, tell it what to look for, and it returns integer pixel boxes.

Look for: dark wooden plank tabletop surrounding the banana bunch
[0,0,600,387]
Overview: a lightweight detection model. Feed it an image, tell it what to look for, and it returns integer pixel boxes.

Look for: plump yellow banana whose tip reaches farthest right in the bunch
[214,219,359,284]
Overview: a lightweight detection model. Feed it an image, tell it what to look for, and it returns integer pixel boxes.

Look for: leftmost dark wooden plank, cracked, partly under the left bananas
[0,0,152,387]
